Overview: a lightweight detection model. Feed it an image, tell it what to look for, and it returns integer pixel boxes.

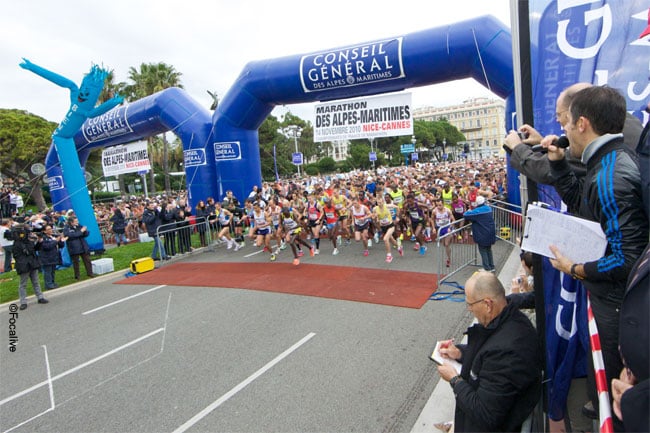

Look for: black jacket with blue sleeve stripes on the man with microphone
[551,136,648,305]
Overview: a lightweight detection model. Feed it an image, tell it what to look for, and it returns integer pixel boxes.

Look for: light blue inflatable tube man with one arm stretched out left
[20,59,123,250]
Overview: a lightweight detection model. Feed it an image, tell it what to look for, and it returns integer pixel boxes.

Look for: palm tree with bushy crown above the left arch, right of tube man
[126,62,183,193]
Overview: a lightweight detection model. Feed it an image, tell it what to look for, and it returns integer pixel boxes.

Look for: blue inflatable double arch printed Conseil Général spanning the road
[46,16,514,250]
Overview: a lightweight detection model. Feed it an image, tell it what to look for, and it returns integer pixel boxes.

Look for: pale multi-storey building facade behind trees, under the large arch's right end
[413,98,506,159]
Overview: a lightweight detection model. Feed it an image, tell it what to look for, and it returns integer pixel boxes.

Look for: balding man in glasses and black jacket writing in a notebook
[438,271,542,432]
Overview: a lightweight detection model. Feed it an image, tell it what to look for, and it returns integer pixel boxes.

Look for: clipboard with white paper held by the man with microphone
[521,203,607,263]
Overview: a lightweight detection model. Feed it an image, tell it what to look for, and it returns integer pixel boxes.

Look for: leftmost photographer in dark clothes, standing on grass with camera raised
[10,224,49,310]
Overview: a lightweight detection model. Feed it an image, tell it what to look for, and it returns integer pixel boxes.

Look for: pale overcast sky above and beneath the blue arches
[0,0,510,122]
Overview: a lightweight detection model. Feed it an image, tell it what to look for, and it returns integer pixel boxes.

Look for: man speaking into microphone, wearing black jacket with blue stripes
[542,86,649,430]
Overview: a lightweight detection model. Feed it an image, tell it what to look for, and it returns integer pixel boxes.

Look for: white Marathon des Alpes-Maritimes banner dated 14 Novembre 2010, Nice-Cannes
[314,93,413,143]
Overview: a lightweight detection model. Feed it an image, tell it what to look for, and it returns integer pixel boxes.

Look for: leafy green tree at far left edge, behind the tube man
[0,108,57,210]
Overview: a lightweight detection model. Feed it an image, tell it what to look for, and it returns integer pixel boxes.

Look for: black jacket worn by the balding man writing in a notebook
[454,303,542,432]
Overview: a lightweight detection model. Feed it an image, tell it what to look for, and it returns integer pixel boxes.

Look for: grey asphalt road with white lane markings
[0,238,508,433]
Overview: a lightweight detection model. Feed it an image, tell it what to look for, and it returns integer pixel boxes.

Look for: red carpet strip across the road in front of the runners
[117,263,436,308]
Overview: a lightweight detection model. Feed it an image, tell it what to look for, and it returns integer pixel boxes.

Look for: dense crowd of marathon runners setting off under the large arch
[195,158,506,266]
